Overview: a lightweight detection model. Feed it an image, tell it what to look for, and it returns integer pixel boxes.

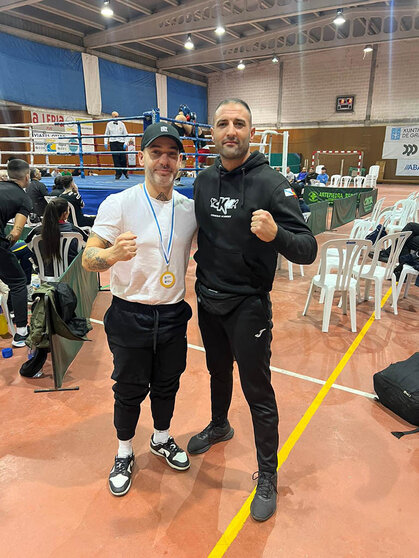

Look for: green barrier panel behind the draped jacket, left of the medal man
[50,252,99,388]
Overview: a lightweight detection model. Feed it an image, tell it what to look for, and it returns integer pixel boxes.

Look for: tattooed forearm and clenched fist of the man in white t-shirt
[82,231,137,271]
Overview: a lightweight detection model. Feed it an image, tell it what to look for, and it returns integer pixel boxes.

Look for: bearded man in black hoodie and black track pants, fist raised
[188,99,317,521]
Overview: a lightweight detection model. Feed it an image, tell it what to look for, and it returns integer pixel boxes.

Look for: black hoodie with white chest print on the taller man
[194,151,317,295]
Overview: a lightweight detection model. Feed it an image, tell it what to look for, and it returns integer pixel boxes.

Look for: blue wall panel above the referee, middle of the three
[99,58,157,116]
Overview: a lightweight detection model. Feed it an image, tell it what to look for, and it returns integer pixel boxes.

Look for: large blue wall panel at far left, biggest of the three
[0,33,86,110]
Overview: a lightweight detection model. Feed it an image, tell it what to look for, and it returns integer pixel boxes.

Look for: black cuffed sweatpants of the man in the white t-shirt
[104,297,192,440]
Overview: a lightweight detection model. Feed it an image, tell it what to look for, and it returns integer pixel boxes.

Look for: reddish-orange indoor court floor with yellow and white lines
[0,185,419,558]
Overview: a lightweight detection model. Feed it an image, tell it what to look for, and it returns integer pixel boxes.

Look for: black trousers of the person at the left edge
[0,240,28,327]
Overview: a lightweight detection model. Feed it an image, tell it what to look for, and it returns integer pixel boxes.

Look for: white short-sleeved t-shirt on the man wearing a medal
[92,184,196,304]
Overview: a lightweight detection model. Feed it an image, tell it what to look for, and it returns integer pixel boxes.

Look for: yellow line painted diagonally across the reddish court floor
[208,287,391,558]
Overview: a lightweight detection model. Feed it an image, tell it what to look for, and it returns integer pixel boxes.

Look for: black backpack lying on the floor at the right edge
[374,353,419,438]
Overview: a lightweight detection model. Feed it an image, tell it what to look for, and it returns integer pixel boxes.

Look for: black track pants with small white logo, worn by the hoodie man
[198,295,279,473]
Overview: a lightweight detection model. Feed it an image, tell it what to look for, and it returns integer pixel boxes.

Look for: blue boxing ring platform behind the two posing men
[41,174,195,215]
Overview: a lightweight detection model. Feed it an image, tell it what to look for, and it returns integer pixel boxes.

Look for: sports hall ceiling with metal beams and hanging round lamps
[0,0,419,83]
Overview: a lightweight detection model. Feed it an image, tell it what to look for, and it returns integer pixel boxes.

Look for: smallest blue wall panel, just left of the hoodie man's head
[167,77,208,123]
